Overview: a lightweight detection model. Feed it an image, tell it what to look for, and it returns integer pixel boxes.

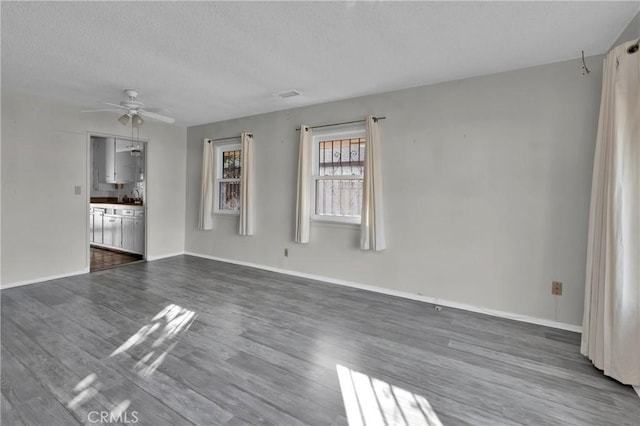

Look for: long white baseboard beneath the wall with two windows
[183,252,582,333]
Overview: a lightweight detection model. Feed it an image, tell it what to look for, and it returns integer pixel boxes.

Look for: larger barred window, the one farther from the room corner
[311,129,366,223]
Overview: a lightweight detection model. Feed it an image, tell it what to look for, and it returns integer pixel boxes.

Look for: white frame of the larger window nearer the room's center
[310,126,367,225]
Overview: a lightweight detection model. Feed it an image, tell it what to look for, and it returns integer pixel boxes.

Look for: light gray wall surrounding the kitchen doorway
[0,92,186,287]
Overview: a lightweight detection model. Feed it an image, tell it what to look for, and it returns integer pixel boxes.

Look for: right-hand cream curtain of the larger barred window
[360,115,387,251]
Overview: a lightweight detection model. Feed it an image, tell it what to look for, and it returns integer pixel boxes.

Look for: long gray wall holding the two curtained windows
[185,56,602,325]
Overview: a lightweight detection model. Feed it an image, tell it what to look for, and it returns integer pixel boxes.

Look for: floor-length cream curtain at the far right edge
[581,42,640,385]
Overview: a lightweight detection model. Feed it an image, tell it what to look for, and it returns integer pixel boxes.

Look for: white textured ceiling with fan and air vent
[1,1,640,126]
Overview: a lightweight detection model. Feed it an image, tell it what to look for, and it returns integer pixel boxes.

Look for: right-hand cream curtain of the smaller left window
[240,133,255,235]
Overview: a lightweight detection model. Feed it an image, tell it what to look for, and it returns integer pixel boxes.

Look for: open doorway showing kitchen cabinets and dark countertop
[88,134,147,272]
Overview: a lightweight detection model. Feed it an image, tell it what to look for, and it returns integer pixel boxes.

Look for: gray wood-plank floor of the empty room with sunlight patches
[1,256,640,426]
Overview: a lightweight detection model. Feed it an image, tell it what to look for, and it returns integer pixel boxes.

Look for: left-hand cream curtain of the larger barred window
[295,125,312,243]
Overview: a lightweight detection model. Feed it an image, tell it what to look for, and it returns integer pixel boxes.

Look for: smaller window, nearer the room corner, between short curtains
[215,143,242,214]
